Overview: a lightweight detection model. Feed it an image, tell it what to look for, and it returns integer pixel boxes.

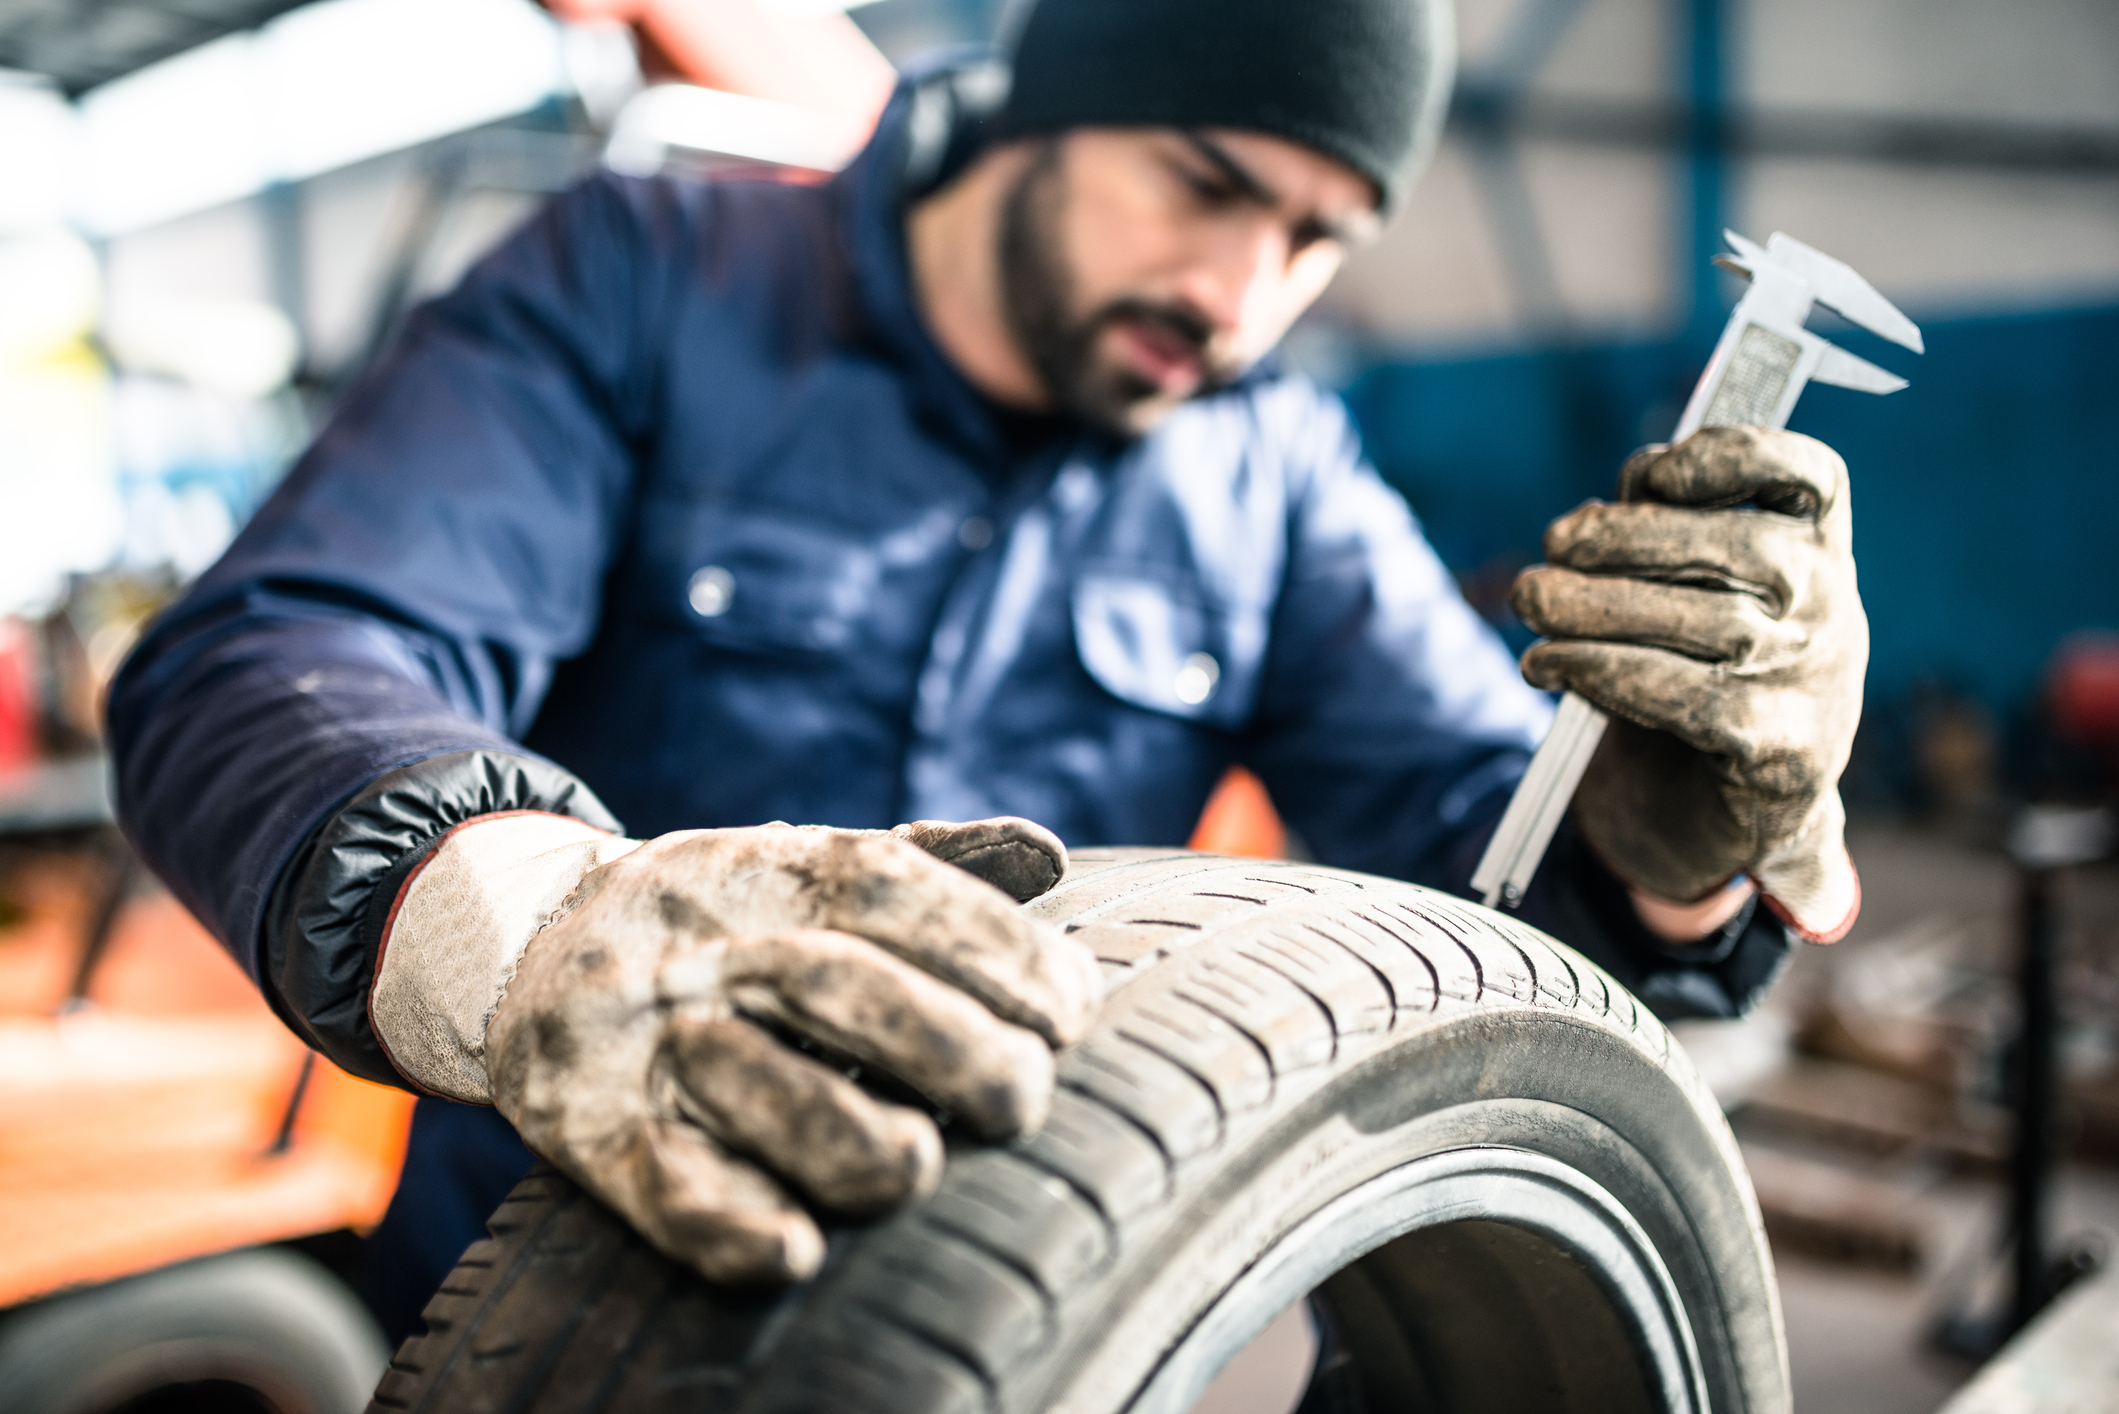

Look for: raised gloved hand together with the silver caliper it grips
[1473,233,1920,941]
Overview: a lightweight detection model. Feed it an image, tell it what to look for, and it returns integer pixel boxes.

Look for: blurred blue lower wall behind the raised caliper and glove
[1348,307,2119,712]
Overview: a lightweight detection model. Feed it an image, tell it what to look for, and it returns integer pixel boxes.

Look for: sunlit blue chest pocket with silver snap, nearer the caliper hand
[1072,568,1267,731]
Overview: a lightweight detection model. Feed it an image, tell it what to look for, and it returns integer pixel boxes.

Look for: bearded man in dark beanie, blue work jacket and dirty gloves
[110,0,1865,1331]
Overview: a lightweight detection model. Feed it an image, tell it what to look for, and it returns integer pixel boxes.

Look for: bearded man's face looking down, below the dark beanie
[1000,127,1379,435]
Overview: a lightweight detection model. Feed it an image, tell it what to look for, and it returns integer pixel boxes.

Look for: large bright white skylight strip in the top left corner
[74,0,564,235]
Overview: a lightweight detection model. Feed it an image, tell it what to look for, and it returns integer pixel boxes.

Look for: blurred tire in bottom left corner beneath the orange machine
[0,1247,390,1414]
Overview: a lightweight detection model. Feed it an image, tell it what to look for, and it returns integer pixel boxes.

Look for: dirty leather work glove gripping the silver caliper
[1513,428,1869,941]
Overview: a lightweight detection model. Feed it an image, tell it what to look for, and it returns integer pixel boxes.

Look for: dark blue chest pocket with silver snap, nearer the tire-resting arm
[665,507,882,653]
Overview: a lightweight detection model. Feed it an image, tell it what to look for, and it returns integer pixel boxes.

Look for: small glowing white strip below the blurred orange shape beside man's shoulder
[604,83,869,174]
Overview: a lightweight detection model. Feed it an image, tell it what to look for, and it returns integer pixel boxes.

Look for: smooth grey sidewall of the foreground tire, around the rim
[902,1007,1780,1414]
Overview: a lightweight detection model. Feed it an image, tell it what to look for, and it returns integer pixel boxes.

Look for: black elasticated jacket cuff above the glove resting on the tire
[259,750,621,1088]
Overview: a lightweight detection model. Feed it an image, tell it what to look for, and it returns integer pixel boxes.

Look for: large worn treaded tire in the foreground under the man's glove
[371,850,1788,1414]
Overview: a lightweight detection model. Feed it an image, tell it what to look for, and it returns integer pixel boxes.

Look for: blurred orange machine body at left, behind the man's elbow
[0,856,413,1306]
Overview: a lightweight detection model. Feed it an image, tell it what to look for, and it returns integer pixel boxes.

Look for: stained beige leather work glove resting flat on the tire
[371,814,1100,1283]
